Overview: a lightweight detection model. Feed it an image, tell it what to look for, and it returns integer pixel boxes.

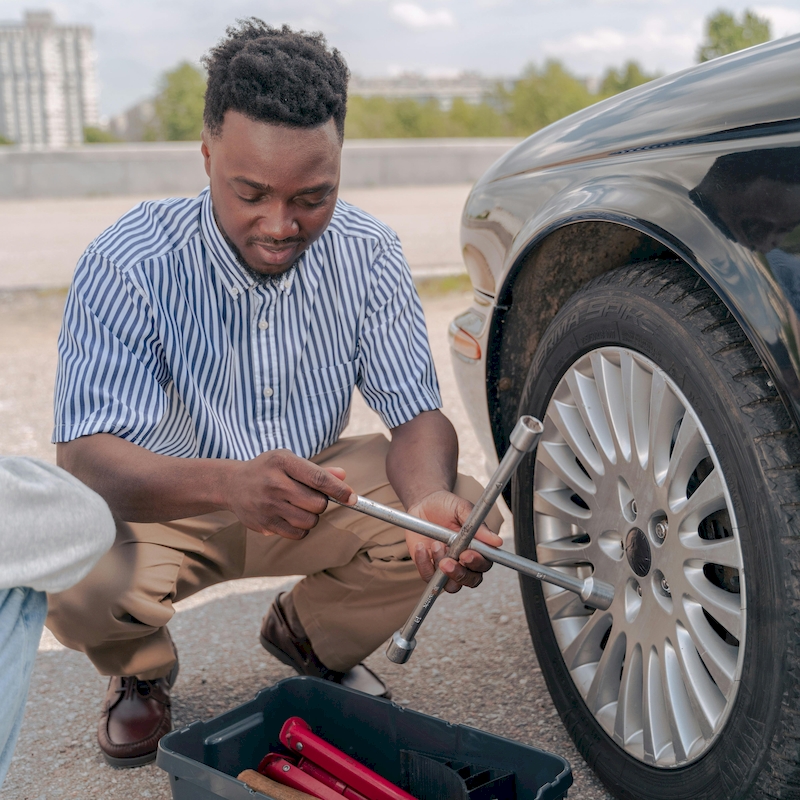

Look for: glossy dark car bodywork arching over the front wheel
[454,36,800,461]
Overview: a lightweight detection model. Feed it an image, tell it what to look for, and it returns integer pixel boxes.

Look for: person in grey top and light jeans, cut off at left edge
[0,456,114,786]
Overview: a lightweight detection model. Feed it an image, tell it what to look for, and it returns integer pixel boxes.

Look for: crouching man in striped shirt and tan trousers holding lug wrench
[48,19,500,766]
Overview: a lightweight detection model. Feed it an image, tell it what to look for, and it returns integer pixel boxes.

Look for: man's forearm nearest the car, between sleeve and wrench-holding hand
[386,411,458,508]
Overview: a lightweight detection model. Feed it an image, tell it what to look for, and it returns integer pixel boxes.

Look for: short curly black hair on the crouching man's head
[203,17,350,139]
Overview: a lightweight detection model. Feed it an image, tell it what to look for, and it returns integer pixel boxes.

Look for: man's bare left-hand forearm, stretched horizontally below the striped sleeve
[57,433,231,522]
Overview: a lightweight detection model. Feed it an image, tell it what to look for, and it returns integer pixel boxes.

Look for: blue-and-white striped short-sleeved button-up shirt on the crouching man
[53,189,441,460]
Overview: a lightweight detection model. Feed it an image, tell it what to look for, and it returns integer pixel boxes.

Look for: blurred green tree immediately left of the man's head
[151,61,206,141]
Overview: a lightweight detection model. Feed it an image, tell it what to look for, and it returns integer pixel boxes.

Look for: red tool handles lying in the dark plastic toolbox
[258,717,414,800]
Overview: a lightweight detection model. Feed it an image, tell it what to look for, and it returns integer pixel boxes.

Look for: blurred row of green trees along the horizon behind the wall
[86,11,771,142]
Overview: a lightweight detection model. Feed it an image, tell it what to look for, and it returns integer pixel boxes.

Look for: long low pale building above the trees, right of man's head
[347,72,509,111]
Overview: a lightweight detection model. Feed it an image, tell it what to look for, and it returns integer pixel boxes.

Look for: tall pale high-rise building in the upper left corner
[0,11,97,148]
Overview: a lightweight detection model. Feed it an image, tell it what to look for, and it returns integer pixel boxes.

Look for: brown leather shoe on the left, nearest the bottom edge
[97,662,178,767]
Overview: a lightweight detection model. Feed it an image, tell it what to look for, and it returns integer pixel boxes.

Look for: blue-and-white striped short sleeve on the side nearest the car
[357,237,442,428]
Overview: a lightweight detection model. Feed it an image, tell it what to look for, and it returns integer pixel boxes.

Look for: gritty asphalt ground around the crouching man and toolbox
[0,190,610,800]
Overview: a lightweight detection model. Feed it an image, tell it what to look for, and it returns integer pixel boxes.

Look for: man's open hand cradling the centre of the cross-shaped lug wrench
[406,491,503,593]
